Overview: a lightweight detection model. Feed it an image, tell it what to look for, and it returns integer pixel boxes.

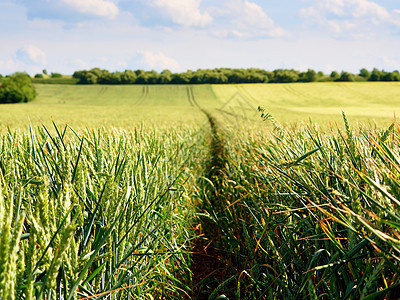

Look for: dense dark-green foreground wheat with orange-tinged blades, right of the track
[192,115,400,299]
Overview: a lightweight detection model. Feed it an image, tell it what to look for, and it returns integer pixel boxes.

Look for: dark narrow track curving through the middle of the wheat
[188,108,236,300]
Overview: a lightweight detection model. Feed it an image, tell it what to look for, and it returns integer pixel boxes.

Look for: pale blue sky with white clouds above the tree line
[0,0,400,75]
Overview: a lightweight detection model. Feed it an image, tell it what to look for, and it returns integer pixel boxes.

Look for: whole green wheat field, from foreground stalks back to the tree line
[0,82,400,300]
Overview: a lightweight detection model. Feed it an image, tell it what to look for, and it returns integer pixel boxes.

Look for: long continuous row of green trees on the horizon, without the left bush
[73,68,400,84]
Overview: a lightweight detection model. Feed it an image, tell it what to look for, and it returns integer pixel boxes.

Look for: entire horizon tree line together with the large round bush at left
[0,68,400,103]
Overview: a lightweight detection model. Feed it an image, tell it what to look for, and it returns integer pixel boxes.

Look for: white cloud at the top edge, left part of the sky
[61,0,119,18]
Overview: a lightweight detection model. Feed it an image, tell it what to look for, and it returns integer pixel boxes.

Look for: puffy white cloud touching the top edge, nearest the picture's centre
[151,0,212,27]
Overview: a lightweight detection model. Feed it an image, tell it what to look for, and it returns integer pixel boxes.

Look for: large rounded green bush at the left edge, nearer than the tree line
[0,73,36,103]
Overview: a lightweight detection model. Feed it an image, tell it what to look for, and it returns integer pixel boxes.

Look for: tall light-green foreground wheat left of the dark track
[0,122,197,299]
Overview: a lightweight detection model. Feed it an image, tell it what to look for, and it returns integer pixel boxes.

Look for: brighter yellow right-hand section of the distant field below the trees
[213,82,400,123]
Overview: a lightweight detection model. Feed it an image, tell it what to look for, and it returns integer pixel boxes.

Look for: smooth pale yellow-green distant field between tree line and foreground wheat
[0,82,400,128]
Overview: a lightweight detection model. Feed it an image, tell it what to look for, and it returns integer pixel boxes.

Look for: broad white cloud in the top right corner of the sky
[299,0,400,36]
